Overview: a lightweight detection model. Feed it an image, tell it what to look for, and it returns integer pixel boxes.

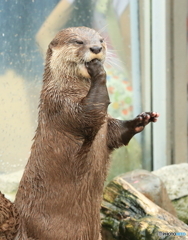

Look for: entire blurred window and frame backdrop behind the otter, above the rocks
[0,0,188,191]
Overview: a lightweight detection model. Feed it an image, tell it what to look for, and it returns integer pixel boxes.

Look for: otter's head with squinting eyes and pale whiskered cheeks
[46,27,106,78]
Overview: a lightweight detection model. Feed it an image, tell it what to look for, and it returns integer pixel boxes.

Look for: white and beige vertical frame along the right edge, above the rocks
[151,0,187,170]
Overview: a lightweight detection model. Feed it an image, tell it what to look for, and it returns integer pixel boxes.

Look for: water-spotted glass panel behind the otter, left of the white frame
[0,0,151,199]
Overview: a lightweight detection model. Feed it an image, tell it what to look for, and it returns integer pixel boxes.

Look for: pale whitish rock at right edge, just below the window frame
[152,163,188,200]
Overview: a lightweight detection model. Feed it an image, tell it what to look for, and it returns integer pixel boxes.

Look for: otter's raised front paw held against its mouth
[85,59,106,80]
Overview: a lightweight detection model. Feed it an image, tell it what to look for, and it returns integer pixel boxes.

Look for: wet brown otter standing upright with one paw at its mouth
[15,27,159,240]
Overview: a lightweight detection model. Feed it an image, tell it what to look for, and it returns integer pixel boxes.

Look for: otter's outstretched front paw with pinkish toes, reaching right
[127,112,159,134]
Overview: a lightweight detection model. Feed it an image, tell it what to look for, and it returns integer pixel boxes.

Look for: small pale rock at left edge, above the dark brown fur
[0,170,23,201]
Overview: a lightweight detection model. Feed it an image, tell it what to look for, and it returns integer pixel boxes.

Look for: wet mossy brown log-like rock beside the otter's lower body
[101,177,188,240]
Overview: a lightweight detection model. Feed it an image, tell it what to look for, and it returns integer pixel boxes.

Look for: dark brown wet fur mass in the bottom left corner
[0,192,19,240]
